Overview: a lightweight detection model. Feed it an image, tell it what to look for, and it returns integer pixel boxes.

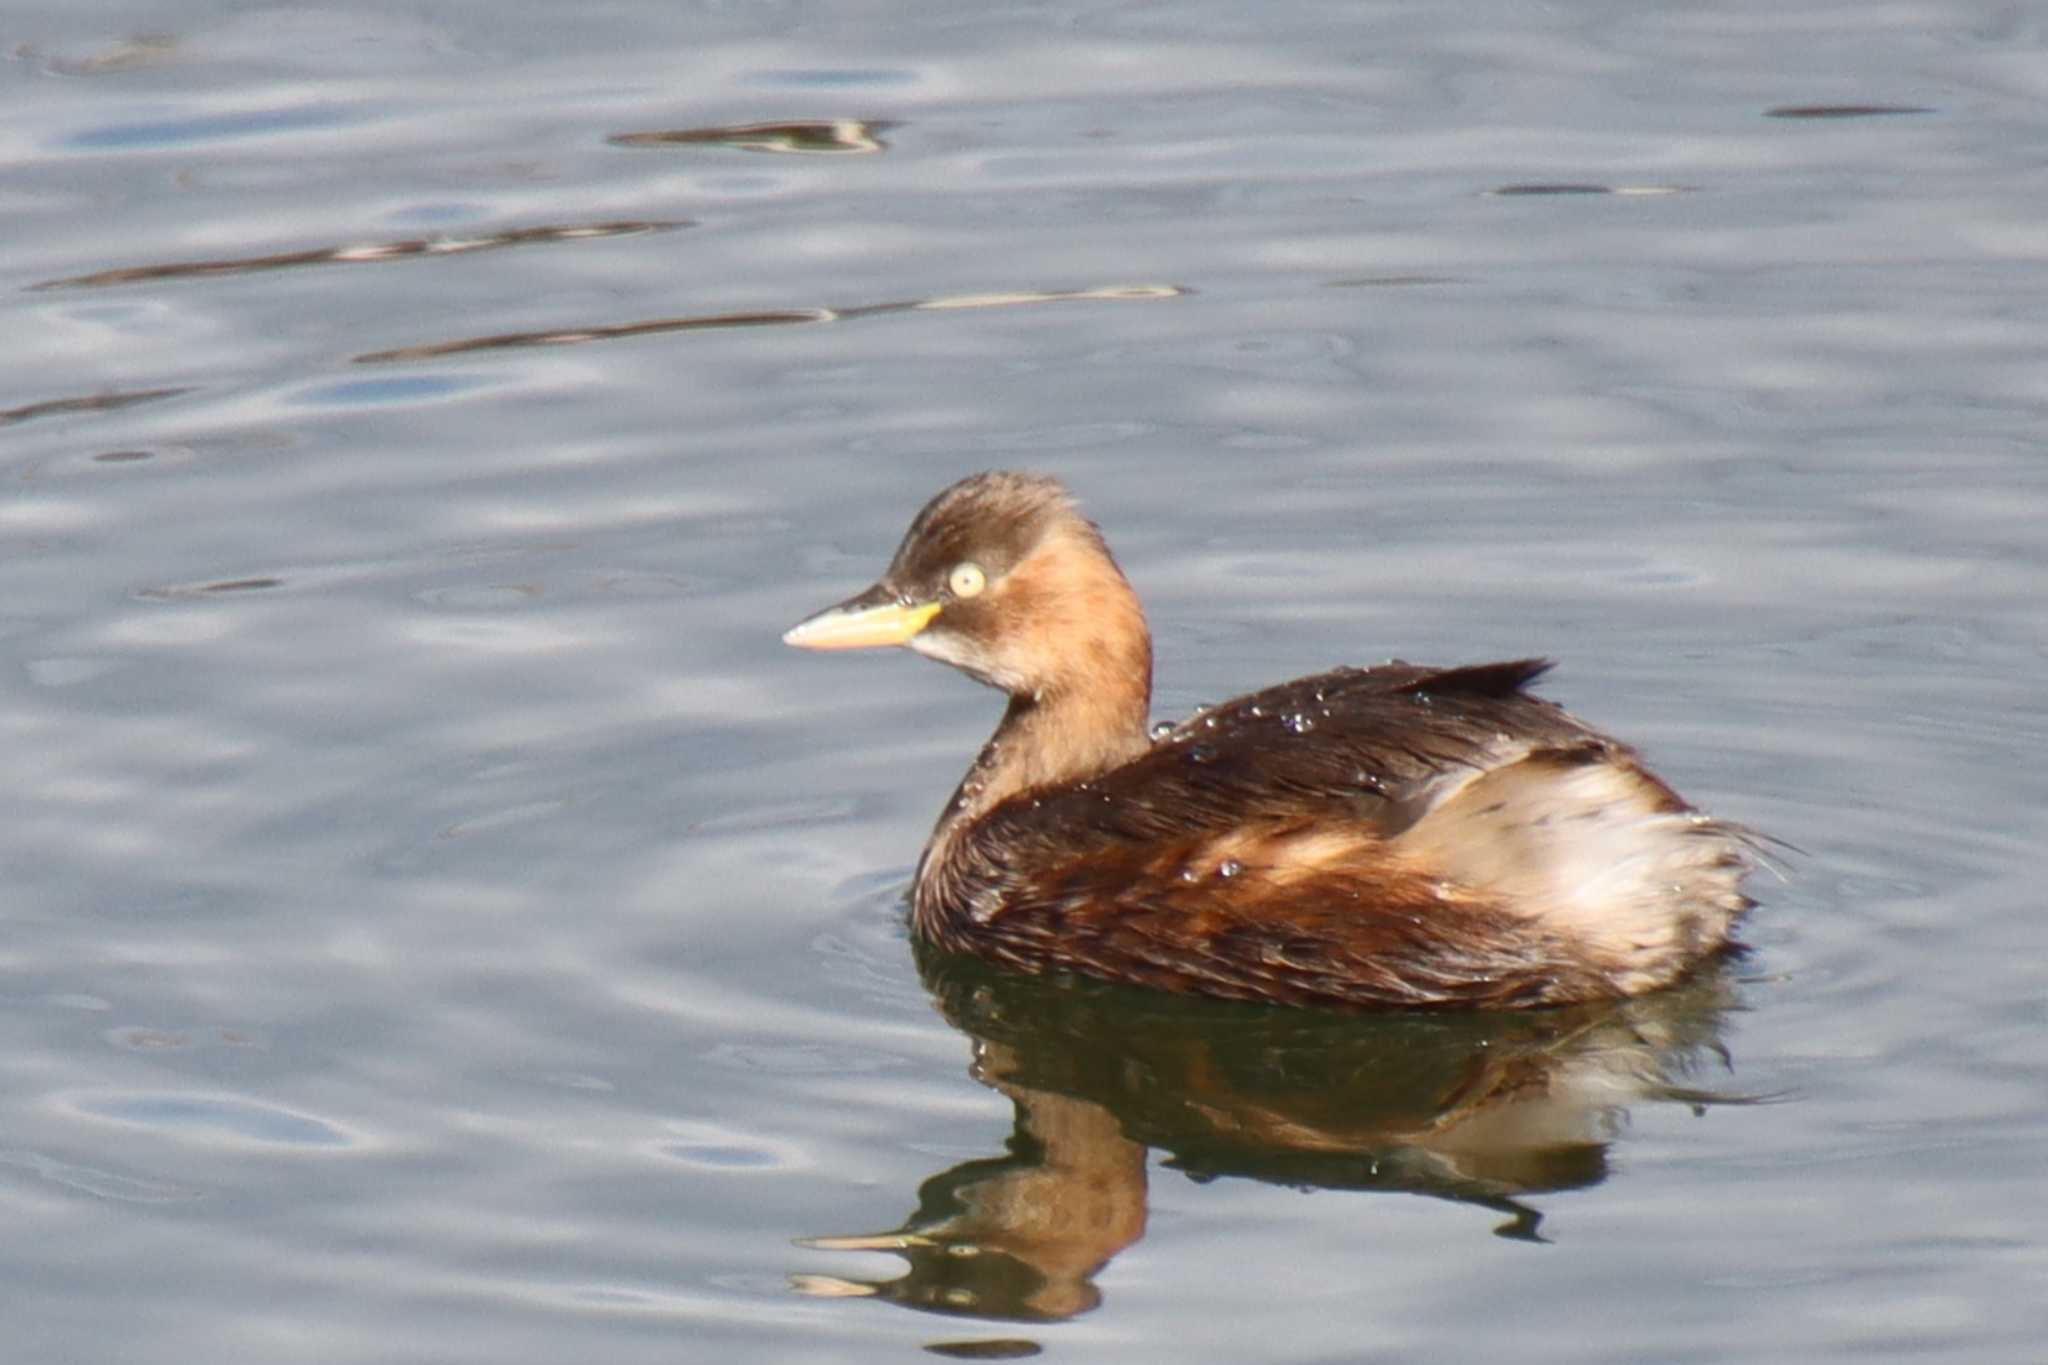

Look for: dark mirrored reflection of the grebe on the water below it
[793,950,1733,1322]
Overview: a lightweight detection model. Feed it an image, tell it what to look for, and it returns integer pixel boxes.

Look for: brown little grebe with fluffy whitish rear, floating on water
[782,473,1751,1007]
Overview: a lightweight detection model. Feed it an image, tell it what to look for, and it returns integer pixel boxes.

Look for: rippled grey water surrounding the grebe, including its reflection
[0,0,2048,1365]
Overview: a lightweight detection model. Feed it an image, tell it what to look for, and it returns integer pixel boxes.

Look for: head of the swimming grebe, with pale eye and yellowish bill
[782,471,1151,700]
